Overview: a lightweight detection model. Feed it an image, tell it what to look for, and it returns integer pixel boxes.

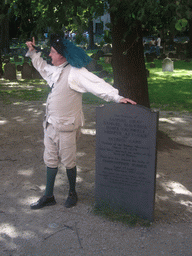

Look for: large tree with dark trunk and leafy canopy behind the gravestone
[8,0,186,107]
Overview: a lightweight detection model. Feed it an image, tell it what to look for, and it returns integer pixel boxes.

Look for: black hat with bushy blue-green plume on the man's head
[50,34,91,68]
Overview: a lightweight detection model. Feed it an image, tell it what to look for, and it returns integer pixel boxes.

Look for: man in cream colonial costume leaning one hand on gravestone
[26,34,136,209]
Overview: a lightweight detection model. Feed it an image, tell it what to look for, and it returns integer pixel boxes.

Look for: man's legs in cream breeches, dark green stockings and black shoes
[31,125,77,209]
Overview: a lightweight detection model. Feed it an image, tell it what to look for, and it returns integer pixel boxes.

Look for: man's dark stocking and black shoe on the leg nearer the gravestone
[65,166,78,208]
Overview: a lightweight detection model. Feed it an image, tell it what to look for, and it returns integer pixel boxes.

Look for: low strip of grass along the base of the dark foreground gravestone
[93,203,151,227]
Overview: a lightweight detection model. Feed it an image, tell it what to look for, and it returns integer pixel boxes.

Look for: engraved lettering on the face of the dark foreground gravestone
[98,115,151,189]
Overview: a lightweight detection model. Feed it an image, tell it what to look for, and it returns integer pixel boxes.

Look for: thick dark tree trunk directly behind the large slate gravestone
[111,14,150,108]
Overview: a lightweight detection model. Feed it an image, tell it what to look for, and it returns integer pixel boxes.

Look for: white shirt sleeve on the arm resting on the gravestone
[68,67,123,103]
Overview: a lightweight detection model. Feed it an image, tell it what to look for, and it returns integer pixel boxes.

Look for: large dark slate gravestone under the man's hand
[95,104,158,221]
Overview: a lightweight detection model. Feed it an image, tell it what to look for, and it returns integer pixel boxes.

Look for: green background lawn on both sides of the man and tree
[0,55,192,112]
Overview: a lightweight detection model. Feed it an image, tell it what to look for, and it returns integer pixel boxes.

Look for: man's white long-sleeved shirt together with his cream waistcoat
[26,50,123,131]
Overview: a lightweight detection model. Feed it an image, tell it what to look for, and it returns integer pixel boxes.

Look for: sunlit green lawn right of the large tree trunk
[146,60,192,112]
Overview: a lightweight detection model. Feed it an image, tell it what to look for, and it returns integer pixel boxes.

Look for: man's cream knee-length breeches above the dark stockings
[44,124,77,169]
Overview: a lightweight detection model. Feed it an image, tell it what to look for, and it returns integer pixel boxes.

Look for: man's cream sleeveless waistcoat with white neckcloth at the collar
[46,65,84,131]
